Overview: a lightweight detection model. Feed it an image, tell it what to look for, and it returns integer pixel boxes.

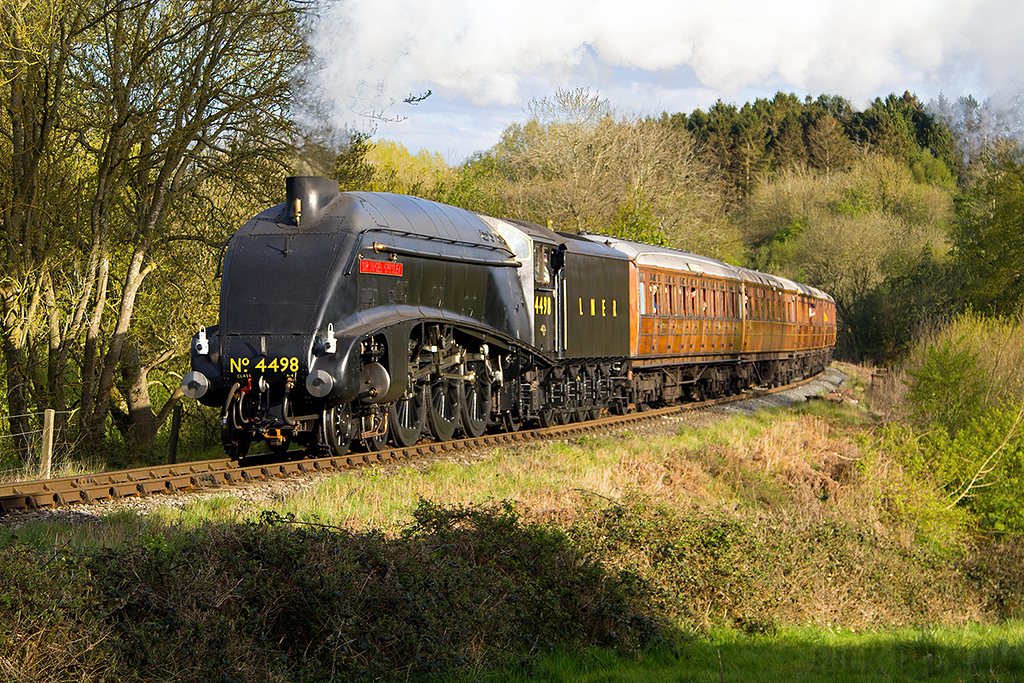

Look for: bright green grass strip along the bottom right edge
[447,622,1024,683]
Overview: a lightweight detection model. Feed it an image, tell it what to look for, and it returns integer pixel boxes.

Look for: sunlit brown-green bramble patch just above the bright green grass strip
[571,498,981,634]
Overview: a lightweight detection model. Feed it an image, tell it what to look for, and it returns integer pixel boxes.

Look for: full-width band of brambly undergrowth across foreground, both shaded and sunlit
[0,496,1024,681]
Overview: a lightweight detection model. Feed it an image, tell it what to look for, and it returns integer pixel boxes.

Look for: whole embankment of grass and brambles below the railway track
[0,376,1024,682]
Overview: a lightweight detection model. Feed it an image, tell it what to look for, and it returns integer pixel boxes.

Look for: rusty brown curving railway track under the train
[0,376,820,515]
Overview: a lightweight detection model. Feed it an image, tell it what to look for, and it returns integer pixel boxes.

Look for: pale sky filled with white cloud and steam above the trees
[311,0,1024,164]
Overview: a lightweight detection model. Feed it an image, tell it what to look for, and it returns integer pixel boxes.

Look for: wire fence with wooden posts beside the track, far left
[0,411,78,479]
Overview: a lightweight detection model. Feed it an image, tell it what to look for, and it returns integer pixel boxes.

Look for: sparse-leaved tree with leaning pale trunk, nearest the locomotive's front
[79,0,306,448]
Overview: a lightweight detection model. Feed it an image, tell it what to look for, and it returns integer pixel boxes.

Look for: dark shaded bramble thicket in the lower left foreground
[0,502,664,681]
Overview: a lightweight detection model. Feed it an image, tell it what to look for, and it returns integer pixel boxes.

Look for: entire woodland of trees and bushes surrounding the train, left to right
[0,0,1024,528]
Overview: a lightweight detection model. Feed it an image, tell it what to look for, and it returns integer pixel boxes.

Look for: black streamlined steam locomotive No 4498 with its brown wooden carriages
[181,176,837,460]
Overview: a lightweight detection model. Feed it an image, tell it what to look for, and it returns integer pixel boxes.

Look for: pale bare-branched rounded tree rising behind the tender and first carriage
[496,89,724,253]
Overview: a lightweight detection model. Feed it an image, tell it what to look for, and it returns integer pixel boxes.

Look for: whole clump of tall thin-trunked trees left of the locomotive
[0,0,306,462]
